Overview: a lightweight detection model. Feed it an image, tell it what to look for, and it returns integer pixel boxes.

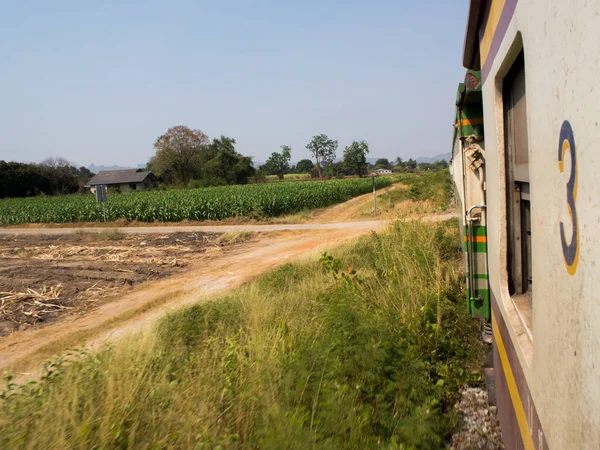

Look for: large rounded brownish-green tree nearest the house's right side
[148,125,209,185]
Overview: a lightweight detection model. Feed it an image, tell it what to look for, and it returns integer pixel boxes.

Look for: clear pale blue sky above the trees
[0,0,468,165]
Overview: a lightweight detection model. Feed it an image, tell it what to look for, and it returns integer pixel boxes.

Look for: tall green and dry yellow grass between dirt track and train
[0,217,481,449]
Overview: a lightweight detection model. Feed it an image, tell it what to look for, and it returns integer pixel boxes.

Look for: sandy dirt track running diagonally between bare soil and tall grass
[0,222,384,380]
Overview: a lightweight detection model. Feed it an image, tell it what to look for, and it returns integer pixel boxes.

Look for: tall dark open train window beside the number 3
[503,53,533,306]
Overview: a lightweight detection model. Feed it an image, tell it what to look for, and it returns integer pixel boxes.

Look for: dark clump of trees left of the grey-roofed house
[0,158,94,198]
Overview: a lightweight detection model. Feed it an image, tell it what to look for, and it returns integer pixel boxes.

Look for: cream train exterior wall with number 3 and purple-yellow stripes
[451,0,600,449]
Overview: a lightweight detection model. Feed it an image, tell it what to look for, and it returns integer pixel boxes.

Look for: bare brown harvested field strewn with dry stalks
[0,233,224,336]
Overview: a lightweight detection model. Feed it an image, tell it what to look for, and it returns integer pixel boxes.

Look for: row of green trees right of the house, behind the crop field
[148,126,448,187]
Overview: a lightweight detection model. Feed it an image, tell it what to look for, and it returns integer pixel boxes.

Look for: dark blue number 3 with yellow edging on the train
[558,120,579,275]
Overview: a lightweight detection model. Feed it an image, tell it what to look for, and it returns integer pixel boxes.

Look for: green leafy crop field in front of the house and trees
[0,178,391,225]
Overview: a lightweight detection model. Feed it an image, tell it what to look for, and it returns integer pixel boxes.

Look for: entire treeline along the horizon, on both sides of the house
[0,126,448,198]
